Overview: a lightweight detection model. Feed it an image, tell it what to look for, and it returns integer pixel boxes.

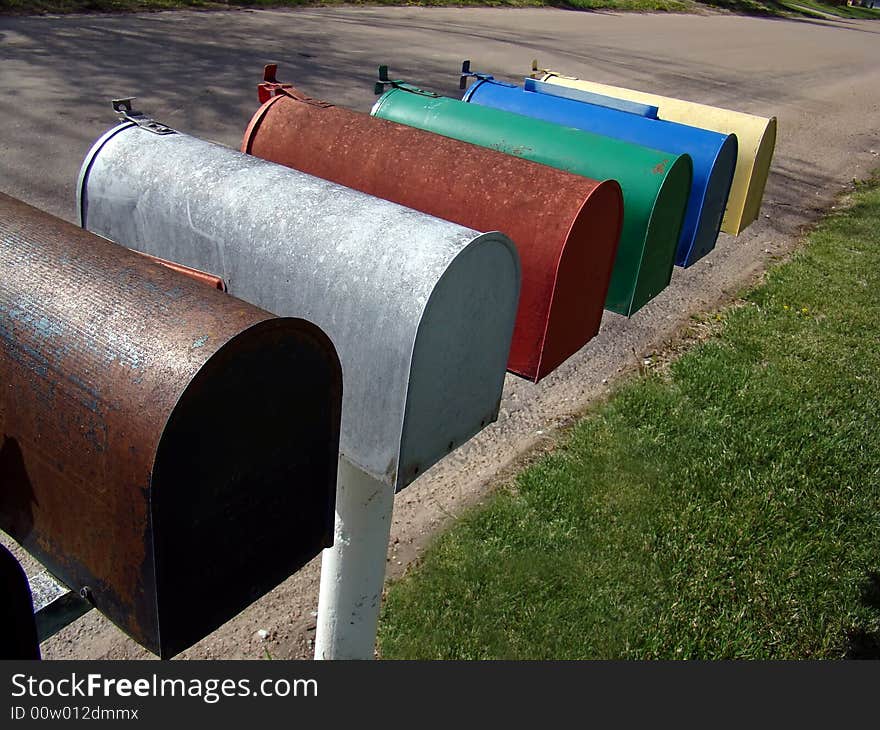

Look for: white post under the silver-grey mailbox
[315,458,394,659]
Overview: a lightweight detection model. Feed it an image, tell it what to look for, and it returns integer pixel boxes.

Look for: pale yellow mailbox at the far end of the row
[532,63,776,236]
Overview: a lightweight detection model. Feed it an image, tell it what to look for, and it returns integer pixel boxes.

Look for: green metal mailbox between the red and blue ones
[372,67,691,315]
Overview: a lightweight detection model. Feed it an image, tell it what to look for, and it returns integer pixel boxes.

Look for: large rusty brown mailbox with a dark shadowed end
[0,195,342,657]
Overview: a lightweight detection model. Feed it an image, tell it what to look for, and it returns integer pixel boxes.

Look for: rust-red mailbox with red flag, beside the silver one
[241,66,623,381]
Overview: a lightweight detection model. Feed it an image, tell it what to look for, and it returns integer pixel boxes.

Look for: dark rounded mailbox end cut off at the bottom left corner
[0,545,40,660]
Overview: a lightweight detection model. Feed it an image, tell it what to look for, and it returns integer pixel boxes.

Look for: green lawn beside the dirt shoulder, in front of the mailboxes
[380,176,880,659]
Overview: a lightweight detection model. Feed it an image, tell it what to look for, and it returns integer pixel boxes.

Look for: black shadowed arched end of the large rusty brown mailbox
[151,318,342,657]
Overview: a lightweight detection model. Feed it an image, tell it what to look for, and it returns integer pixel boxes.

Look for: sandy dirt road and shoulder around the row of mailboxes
[0,8,880,659]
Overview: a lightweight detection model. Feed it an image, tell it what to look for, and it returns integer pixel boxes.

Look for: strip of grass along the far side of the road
[0,0,880,18]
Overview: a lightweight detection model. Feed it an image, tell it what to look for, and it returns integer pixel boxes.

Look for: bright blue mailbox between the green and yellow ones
[462,75,736,266]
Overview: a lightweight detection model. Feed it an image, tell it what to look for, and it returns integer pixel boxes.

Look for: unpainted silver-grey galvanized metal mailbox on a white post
[79,122,519,489]
